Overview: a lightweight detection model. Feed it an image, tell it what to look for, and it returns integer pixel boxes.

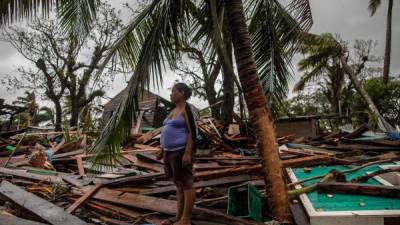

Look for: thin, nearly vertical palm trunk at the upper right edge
[383,0,393,84]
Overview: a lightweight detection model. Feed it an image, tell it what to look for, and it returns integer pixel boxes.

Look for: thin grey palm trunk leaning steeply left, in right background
[340,56,393,131]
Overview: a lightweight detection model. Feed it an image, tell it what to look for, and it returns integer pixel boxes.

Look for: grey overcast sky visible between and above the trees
[0,0,400,108]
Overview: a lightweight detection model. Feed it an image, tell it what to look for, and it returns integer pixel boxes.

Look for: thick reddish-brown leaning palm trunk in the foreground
[225,0,290,222]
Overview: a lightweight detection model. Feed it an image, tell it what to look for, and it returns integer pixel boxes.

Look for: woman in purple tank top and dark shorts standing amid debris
[159,83,196,225]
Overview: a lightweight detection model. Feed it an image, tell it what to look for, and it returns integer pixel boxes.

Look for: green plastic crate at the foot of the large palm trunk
[227,184,263,222]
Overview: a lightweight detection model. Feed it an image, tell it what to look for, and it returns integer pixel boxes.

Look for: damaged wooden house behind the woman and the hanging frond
[102,88,198,131]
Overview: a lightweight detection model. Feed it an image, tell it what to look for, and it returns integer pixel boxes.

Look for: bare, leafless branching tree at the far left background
[0,4,121,130]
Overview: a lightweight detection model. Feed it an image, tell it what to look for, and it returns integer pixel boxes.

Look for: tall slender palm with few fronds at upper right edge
[368,0,393,84]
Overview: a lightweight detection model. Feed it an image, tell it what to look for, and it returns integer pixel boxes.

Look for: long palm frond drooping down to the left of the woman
[89,0,187,165]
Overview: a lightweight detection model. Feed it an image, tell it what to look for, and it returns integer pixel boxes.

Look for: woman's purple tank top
[160,116,189,151]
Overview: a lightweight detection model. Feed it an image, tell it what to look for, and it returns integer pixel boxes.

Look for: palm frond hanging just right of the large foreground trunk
[250,0,312,115]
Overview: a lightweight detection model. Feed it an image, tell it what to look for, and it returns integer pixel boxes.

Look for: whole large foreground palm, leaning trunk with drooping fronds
[0,0,311,221]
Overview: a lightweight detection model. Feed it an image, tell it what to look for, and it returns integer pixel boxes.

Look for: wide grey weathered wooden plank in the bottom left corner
[0,180,87,225]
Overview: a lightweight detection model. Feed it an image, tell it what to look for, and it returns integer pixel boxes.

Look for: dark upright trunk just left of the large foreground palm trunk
[221,15,235,127]
